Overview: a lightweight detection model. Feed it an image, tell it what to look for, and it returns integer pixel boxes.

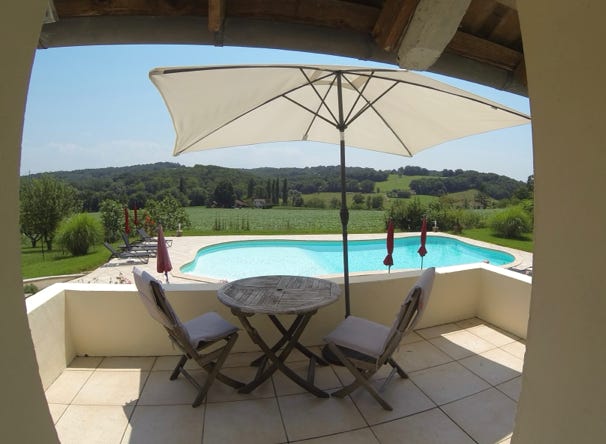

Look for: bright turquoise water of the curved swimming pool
[181,236,514,281]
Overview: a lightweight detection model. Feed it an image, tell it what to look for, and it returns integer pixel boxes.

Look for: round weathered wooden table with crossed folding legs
[217,276,341,398]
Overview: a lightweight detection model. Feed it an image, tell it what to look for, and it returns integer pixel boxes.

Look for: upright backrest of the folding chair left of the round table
[133,267,189,346]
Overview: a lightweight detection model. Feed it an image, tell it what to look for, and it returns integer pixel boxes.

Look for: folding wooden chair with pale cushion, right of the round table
[324,268,435,410]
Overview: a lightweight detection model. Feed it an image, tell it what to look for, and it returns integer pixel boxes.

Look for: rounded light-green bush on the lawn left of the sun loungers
[58,213,103,256]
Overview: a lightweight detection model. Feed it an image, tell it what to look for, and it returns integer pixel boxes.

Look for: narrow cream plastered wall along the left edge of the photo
[0,0,58,444]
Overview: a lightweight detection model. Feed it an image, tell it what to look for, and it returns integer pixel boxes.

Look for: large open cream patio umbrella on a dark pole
[149,65,530,316]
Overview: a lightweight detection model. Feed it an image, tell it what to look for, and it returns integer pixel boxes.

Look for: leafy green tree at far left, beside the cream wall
[20,175,82,250]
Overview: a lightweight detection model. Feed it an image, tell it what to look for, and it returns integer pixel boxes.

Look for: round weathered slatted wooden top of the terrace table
[217,275,341,314]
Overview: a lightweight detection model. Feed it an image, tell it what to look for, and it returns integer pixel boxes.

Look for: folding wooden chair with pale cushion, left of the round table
[133,267,244,407]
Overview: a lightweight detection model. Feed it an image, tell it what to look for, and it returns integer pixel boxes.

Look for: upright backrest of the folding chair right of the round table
[383,267,436,358]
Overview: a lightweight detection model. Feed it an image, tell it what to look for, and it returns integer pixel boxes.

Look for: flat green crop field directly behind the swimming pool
[184,207,385,235]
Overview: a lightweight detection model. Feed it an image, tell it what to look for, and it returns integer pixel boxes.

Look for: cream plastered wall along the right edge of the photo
[512,0,606,444]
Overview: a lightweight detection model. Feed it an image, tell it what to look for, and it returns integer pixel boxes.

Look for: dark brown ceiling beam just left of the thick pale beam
[372,0,419,51]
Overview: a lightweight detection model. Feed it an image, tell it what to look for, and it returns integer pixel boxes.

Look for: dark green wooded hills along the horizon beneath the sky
[29,162,524,212]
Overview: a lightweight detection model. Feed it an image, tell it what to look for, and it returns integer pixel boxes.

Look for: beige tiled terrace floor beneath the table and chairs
[46,318,525,444]
